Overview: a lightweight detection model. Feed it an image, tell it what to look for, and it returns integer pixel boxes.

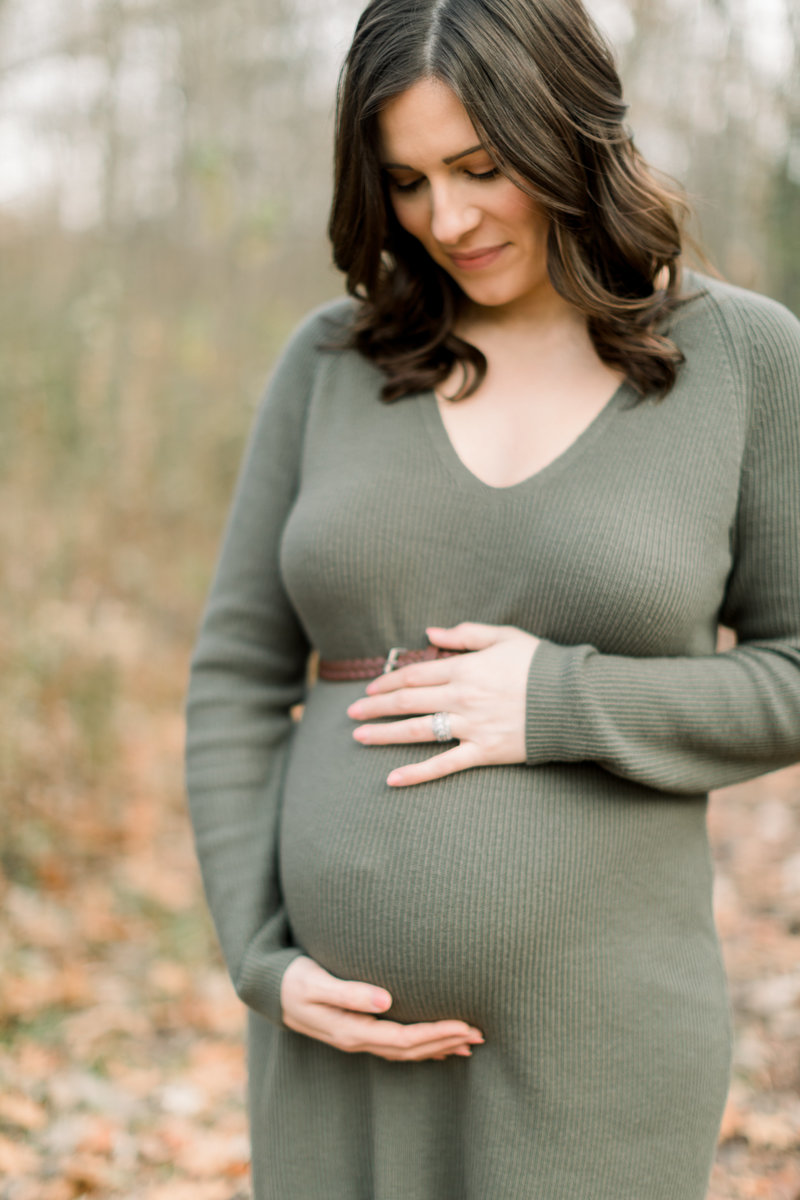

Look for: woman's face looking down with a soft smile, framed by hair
[379,79,557,324]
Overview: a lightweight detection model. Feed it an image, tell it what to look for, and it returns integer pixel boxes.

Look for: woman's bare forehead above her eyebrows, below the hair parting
[378,79,481,166]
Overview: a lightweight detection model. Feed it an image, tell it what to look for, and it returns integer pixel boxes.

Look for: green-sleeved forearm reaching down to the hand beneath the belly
[186,616,305,1021]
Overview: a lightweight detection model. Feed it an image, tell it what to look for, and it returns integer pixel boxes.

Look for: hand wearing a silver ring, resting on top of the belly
[348,622,539,787]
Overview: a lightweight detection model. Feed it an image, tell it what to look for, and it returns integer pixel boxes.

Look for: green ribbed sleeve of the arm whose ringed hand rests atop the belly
[527,290,800,794]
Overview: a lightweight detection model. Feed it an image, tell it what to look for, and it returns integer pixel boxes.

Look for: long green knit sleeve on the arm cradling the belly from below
[186,307,328,1022]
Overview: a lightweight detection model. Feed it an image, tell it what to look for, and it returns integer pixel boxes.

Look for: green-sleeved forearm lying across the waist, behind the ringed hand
[525,640,800,794]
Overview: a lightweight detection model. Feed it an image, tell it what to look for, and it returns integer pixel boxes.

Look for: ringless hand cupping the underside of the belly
[281,955,483,1062]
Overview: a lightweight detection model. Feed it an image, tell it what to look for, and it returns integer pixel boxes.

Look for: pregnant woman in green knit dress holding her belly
[187,0,800,1200]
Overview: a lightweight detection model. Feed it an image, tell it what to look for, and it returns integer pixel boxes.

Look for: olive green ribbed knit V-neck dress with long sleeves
[188,277,800,1200]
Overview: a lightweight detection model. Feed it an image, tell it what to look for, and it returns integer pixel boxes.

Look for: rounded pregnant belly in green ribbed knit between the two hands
[279,684,717,1031]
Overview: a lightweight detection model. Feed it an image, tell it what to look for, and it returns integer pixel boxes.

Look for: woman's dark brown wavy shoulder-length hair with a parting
[329,0,686,401]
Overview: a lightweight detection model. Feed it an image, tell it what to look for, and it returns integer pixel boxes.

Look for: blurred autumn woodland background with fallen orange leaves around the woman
[0,0,800,1200]
